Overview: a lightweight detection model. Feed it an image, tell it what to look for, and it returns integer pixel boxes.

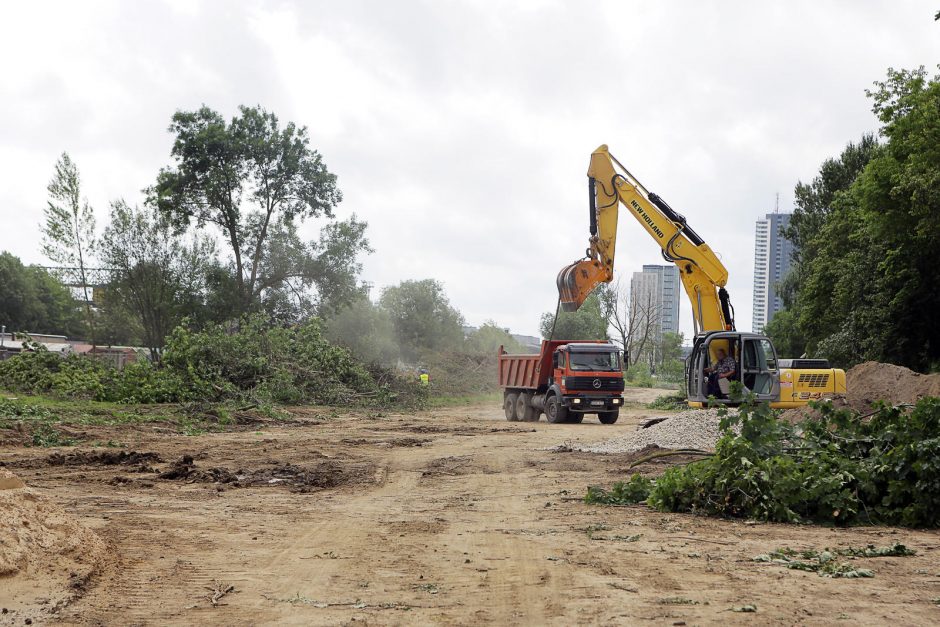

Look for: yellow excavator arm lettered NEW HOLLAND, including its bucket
[557,145,734,334]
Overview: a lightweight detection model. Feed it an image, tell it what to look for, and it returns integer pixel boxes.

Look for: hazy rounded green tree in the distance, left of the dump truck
[379,279,464,358]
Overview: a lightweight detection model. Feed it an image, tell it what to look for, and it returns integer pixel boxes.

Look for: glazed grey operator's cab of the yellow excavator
[686,331,780,407]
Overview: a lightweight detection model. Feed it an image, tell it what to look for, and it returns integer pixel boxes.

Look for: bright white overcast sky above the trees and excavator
[0,0,940,337]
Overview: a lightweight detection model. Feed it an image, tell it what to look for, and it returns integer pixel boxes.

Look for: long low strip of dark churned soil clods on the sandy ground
[158,455,375,492]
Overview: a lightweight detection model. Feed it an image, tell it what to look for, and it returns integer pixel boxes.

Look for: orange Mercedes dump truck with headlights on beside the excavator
[498,340,623,425]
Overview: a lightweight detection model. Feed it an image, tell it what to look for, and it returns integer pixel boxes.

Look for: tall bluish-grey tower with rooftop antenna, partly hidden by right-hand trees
[751,213,793,333]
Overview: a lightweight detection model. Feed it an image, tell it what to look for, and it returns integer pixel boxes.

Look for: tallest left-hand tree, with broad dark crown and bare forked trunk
[148,106,369,313]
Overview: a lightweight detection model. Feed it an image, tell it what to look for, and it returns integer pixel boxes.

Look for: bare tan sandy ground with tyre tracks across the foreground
[0,391,940,625]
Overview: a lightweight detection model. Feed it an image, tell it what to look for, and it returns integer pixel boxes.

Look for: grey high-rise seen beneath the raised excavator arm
[630,265,680,360]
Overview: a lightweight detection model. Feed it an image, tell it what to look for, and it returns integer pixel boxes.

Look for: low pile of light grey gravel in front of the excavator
[572,409,736,453]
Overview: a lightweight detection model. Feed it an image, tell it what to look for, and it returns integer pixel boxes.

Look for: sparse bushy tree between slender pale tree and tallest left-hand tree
[101,200,215,361]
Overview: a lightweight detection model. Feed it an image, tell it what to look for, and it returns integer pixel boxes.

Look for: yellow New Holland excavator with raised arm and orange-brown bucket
[557,145,845,408]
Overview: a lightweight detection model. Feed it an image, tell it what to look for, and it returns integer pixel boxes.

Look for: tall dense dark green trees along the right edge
[784,68,940,370]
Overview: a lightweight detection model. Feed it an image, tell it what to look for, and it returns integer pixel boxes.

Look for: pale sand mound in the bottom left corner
[0,469,107,624]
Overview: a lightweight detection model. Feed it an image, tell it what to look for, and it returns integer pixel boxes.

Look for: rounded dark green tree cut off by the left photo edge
[0,252,82,335]
